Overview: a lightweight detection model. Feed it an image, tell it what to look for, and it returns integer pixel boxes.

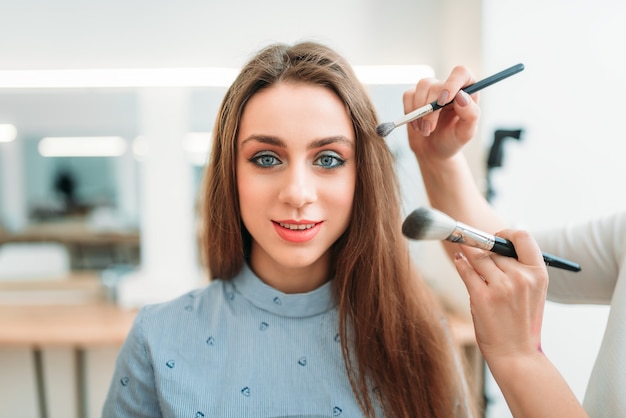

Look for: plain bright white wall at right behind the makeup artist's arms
[483,0,626,417]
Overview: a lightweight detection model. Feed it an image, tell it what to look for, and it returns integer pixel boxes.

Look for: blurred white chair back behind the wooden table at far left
[0,242,71,280]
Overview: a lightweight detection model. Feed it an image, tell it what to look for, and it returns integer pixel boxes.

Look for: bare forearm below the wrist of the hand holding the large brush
[487,353,588,418]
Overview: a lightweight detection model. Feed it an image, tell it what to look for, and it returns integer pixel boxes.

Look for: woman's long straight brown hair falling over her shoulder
[203,42,473,418]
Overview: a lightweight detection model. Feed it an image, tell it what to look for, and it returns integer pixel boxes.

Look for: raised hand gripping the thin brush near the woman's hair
[403,66,480,162]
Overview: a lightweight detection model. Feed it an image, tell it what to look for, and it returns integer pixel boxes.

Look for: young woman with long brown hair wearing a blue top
[104,42,478,418]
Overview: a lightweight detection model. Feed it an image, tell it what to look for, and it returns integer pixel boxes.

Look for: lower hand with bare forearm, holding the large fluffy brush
[454,229,588,418]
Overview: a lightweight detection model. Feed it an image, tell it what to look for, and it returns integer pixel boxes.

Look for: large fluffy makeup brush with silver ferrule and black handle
[402,207,580,271]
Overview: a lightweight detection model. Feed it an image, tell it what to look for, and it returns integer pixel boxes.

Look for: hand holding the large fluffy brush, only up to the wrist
[455,229,548,368]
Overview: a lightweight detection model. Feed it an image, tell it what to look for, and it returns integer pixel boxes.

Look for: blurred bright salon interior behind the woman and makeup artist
[0,0,626,418]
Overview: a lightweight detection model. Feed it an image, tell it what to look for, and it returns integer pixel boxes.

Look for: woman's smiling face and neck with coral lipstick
[237,82,356,293]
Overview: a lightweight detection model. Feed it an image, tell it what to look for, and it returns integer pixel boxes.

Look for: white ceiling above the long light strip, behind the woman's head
[0,0,438,70]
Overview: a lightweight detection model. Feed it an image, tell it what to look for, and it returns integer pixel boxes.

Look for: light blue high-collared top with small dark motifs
[102,265,382,418]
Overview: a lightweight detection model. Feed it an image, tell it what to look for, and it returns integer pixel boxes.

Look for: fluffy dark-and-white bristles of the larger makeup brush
[402,207,456,240]
